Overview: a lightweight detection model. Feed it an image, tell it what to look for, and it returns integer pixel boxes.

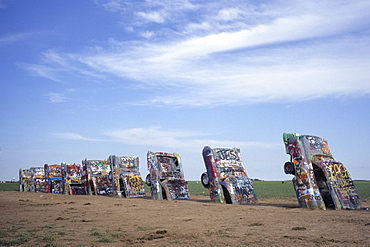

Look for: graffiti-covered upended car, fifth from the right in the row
[82,159,113,195]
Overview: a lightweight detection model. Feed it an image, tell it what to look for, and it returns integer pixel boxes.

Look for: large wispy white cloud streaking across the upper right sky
[24,1,370,106]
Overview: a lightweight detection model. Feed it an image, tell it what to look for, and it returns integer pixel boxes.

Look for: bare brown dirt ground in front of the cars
[0,191,370,247]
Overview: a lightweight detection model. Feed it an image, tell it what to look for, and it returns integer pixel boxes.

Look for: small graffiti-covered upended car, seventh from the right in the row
[44,164,65,194]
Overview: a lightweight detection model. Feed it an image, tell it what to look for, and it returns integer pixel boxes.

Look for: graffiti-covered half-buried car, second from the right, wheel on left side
[201,146,258,204]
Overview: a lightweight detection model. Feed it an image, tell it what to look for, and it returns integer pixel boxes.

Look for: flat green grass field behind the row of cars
[4,181,370,199]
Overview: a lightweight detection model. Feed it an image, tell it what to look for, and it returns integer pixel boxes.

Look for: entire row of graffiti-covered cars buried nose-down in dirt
[19,133,361,209]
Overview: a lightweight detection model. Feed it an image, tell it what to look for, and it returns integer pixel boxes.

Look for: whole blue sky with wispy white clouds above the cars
[0,0,370,180]
